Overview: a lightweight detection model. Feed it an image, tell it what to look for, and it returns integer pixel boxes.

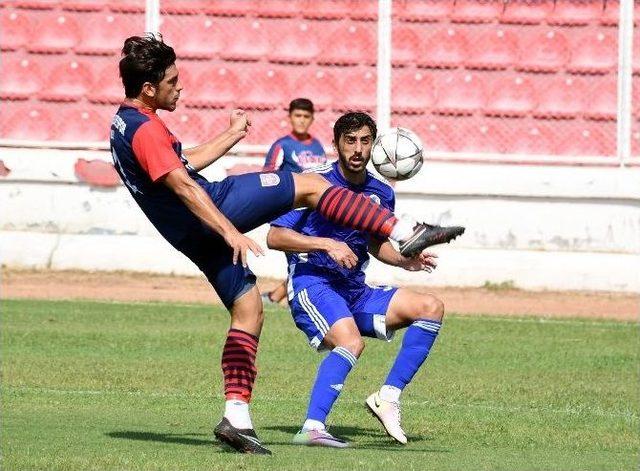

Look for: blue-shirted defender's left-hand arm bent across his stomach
[267,226,358,269]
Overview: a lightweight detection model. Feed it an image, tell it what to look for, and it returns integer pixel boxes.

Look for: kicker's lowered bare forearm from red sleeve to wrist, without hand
[163,168,237,238]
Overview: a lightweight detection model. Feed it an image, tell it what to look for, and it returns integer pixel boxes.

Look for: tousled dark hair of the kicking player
[120,33,176,98]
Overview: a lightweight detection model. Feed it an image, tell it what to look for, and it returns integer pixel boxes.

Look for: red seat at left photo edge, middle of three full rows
[0,54,42,100]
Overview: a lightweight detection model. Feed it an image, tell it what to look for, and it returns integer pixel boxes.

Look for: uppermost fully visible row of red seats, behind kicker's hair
[0,10,624,74]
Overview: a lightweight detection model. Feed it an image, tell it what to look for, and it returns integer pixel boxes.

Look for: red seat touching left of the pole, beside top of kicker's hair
[76,12,144,55]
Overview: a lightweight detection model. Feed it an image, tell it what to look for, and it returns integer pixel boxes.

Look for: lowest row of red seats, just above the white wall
[0,103,615,155]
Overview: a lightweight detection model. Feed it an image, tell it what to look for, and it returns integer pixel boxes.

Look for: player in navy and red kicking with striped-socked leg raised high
[111,35,460,454]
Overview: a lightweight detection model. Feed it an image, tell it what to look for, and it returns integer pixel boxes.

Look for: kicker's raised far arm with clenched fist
[183,110,251,171]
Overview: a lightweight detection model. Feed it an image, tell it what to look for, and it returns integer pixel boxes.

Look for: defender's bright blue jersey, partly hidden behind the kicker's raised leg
[271,162,395,292]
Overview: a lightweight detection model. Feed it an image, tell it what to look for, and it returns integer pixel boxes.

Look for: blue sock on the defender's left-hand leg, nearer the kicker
[307,347,357,424]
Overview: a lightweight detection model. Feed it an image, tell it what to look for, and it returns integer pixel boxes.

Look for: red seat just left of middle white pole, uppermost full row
[318,23,377,65]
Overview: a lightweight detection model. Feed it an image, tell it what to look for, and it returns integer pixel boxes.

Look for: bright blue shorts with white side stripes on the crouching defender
[289,282,398,350]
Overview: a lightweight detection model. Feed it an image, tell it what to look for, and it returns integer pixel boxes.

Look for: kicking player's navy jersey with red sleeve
[111,104,210,246]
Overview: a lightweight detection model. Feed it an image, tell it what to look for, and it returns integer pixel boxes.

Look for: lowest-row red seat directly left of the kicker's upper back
[52,106,111,142]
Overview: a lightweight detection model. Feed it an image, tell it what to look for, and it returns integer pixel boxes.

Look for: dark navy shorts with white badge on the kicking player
[177,172,295,309]
